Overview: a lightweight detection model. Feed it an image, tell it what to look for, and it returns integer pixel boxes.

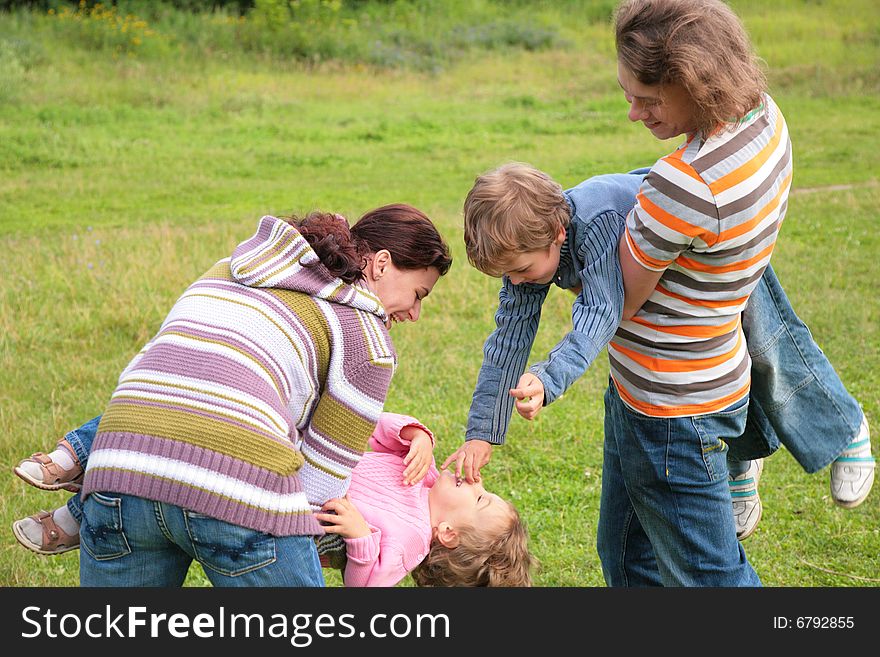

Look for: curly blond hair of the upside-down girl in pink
[411,502,535,586]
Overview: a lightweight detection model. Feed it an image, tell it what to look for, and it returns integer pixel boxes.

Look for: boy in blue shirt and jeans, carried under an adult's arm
[443,163,874,539]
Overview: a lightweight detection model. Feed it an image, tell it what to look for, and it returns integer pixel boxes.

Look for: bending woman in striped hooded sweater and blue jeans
[16,205,452,586]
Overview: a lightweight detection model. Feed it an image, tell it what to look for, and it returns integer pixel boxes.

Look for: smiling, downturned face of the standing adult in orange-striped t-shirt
[617,62,696,139]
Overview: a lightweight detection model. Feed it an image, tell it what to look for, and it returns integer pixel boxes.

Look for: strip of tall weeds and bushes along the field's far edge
[0,0,616,70]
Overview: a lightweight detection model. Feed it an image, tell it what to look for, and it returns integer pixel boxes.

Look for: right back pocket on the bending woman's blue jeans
[184,511,276,577]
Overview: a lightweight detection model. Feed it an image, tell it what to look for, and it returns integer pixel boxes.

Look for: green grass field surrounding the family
[0,0,880,587]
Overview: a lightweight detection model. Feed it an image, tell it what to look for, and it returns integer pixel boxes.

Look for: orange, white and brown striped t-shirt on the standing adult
[608,95,792,417]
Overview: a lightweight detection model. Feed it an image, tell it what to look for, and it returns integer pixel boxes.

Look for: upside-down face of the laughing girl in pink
[428,470,510,529]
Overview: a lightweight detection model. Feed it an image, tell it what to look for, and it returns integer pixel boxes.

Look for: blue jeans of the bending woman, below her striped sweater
[79,493,324,587]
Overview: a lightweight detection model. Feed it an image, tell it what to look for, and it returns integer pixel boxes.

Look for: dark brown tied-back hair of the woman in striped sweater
[284,203,452,283]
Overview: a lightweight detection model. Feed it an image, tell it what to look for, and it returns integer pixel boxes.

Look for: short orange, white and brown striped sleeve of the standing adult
[626,151,719,271]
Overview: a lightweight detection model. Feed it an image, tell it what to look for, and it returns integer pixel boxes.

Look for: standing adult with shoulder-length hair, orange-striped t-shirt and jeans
[598,0,792,586]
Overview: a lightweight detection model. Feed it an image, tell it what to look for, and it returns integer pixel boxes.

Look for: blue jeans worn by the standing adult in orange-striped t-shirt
[596,382,761,586]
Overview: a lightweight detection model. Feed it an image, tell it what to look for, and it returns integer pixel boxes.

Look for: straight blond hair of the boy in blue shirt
[464,162,571,276]
